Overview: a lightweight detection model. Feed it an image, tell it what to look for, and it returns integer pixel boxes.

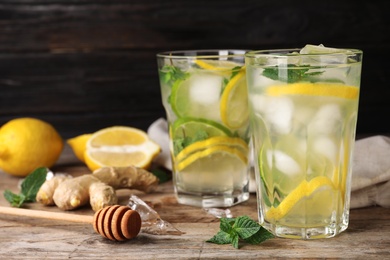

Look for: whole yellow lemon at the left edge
[0,117,64,177]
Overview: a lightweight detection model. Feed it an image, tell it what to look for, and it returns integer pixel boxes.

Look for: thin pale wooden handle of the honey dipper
[0,206,93,224]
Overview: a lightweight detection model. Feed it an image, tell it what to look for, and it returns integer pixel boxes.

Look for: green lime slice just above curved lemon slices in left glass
[172,117,232,139]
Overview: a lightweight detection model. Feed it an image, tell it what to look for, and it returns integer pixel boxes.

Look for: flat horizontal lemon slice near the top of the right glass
[266,83,359,99]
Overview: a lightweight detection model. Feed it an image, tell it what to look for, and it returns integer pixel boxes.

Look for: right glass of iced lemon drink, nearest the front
[246,46,362,239]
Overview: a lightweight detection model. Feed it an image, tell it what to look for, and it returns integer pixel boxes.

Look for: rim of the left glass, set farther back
[156,49,249,59]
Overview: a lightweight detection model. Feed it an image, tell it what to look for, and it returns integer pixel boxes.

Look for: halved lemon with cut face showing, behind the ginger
[84,126,161,171]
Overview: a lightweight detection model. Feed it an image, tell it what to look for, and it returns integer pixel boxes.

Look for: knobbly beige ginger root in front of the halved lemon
[36,166,158,211]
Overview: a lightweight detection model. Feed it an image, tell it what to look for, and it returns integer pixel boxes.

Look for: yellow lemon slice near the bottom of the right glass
[266,176,337,222]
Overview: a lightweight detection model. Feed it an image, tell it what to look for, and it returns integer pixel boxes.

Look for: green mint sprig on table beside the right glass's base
[206,216,274,249]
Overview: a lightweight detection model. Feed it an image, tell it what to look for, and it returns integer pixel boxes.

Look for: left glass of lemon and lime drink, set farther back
[157,50,249,207]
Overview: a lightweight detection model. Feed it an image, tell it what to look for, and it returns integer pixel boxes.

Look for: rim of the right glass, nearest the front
[245,48,363,58]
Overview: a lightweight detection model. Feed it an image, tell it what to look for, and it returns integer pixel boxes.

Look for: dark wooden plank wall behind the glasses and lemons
[0,0,390,138]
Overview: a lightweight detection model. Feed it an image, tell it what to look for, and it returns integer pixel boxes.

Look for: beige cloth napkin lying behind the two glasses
[148,118,390,208]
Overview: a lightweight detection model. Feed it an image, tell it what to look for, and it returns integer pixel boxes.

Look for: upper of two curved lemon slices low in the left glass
[176,136,249,162]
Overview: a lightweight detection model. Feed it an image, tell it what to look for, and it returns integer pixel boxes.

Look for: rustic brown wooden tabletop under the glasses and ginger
[0,147,390,259]
